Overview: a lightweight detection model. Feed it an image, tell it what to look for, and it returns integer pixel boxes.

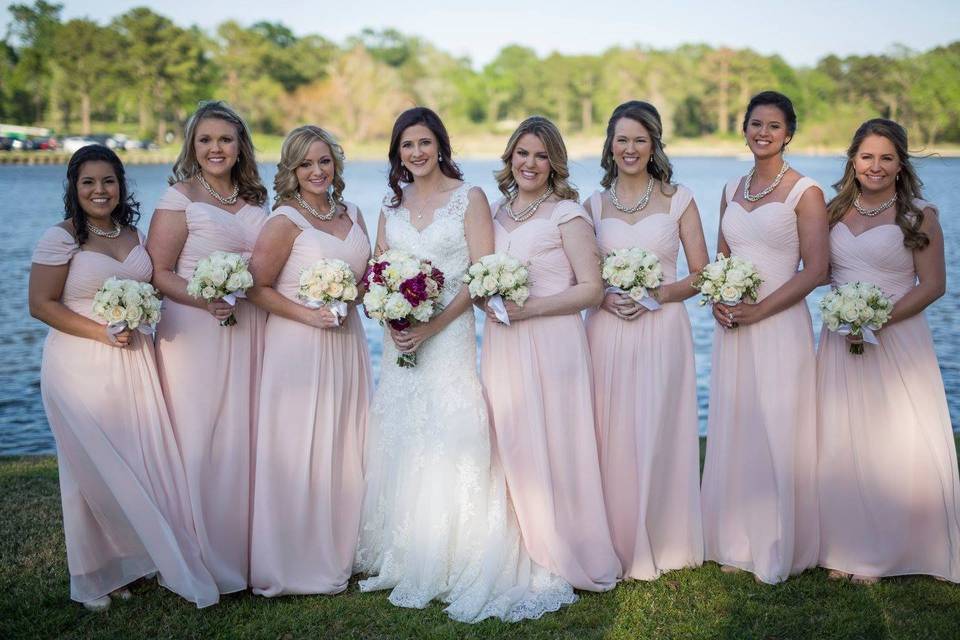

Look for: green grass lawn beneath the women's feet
[0,442,960,640]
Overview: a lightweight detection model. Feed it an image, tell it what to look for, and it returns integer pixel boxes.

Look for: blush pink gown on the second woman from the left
[155,187,267,593]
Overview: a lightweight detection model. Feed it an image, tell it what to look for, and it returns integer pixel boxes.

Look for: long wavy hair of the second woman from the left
[167,100,267,206]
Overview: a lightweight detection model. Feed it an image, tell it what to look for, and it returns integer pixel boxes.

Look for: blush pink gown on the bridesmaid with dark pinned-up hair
[702,177,819,584]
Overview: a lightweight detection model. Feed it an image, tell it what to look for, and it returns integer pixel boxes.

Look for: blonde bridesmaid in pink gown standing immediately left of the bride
[250,126,371,596]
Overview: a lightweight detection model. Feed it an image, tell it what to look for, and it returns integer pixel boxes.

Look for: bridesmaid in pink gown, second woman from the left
[147,101,267,593]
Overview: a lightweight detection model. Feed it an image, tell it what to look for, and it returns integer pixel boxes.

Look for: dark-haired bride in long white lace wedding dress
[355,107,576,622]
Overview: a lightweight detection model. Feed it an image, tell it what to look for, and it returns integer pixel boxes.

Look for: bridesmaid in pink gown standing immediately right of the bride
[481,116,620,591]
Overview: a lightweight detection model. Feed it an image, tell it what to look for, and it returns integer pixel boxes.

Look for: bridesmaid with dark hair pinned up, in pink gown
[702,91,828,583]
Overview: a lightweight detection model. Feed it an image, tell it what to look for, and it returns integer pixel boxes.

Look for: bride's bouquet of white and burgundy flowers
[363,249,443,367]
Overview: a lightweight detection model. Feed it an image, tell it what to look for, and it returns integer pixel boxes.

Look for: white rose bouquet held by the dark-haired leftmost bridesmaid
[93,277,160,339]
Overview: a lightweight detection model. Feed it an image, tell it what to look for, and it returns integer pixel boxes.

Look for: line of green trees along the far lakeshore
[0,0,960,145]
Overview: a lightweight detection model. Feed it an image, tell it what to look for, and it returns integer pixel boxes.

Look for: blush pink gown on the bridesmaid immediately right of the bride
[481,200,620,591]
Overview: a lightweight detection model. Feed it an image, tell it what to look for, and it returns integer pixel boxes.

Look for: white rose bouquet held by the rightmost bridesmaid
[820,282,893,355]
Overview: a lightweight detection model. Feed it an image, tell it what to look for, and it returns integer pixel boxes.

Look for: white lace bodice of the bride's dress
[383,182,471,305]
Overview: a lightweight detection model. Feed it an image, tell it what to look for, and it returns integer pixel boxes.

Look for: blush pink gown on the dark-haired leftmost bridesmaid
[33,226,220,607]
